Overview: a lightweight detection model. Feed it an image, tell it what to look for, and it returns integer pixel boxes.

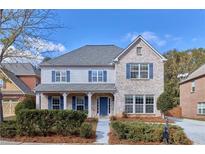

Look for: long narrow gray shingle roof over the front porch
[35,84,116,92]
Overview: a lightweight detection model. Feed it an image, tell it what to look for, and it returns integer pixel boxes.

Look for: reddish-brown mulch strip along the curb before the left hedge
[2,135,96,144]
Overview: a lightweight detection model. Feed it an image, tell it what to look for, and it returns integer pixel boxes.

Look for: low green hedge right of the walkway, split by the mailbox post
[111,121,191,144]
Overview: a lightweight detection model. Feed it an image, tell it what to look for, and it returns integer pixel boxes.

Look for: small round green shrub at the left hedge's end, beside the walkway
[80,123,93,138]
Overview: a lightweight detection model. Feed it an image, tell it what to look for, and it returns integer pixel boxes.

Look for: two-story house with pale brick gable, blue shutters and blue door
[35,36,166,117]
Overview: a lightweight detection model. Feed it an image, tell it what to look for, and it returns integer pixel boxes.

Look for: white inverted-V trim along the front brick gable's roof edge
[114,35,167,62]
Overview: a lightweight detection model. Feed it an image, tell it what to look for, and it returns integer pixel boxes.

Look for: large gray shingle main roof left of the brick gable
[41,45,123,66]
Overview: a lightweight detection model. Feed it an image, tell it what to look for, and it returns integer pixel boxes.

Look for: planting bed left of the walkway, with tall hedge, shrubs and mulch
[0,110,97,144]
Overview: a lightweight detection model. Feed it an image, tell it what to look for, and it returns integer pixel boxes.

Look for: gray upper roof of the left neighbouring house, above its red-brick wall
[1,63,39,76]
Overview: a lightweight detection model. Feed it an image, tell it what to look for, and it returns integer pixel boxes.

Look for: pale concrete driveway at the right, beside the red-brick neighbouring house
[169,117,205,144]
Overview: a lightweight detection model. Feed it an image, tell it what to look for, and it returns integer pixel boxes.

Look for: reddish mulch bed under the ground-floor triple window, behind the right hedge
[113,117,174,123]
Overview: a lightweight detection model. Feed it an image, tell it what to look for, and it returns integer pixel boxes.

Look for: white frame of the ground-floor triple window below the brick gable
[124,94,156,114]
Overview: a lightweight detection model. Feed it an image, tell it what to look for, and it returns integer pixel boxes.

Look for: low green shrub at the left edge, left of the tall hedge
[0,121,17,138]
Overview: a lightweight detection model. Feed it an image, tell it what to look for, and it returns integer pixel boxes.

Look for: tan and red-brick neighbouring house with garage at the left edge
[0,63,40,116]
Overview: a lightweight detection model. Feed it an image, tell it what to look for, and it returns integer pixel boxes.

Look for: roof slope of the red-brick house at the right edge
[181,64,205,83]
